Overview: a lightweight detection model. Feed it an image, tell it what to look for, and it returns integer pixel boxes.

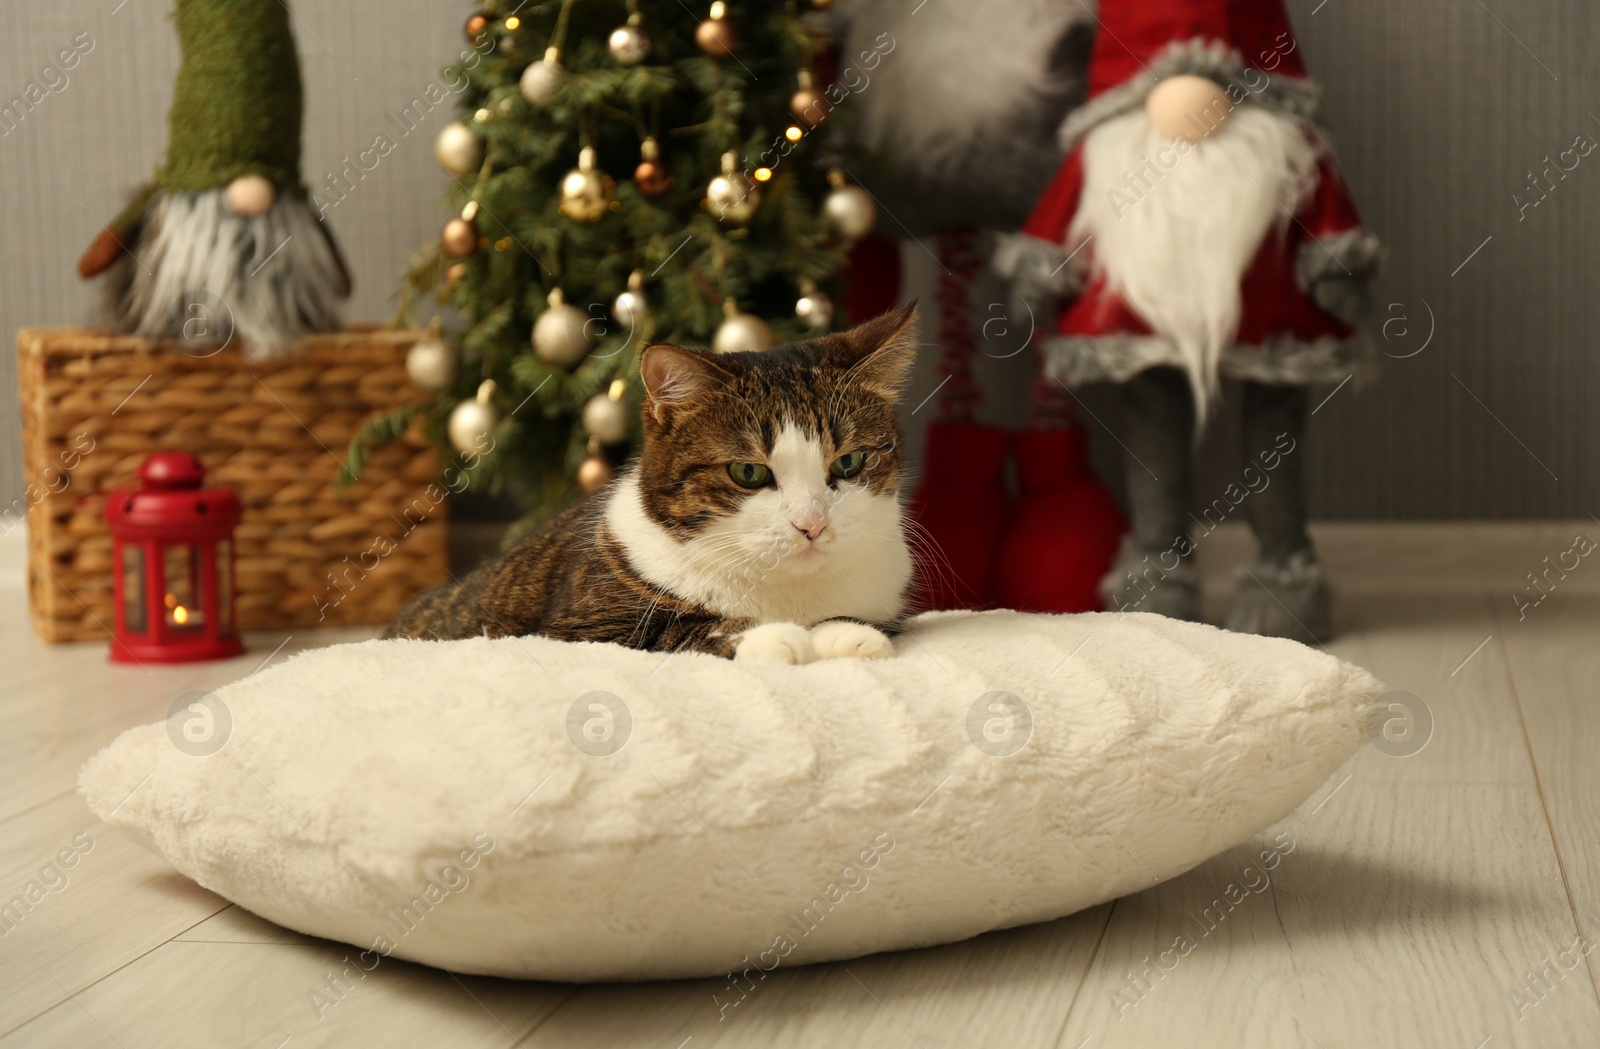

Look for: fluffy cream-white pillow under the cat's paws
[80,612,1381,980]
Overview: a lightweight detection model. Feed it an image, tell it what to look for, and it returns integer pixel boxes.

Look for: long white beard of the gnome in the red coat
[1067,106,1320,419]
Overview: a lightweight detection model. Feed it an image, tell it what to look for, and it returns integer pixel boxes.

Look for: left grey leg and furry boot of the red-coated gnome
[1101,368,1200,620]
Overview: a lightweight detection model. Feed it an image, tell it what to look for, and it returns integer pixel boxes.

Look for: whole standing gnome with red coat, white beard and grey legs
[994,0,1382,640]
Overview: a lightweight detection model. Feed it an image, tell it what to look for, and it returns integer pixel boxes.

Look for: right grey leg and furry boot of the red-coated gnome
[1227,382,1333,643]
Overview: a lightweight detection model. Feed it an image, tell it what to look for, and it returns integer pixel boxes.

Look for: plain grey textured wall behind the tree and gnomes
[0,0,1600,518]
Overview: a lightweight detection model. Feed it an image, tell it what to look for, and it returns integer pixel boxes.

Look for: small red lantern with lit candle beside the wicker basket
[106,451,245,664]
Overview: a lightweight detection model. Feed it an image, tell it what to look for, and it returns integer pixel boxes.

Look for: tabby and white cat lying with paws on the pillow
[386,305,917,664]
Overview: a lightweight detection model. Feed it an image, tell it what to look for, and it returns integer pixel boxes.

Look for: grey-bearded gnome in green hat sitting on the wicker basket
[78,0,350,358]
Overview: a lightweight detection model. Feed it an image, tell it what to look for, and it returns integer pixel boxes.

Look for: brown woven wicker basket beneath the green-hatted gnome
[18,328,448,641]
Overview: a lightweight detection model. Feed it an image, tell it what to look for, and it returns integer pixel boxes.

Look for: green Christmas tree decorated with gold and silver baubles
[349,0,874,525]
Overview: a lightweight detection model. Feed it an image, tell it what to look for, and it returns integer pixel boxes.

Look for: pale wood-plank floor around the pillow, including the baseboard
[0,521,1600,1049]
